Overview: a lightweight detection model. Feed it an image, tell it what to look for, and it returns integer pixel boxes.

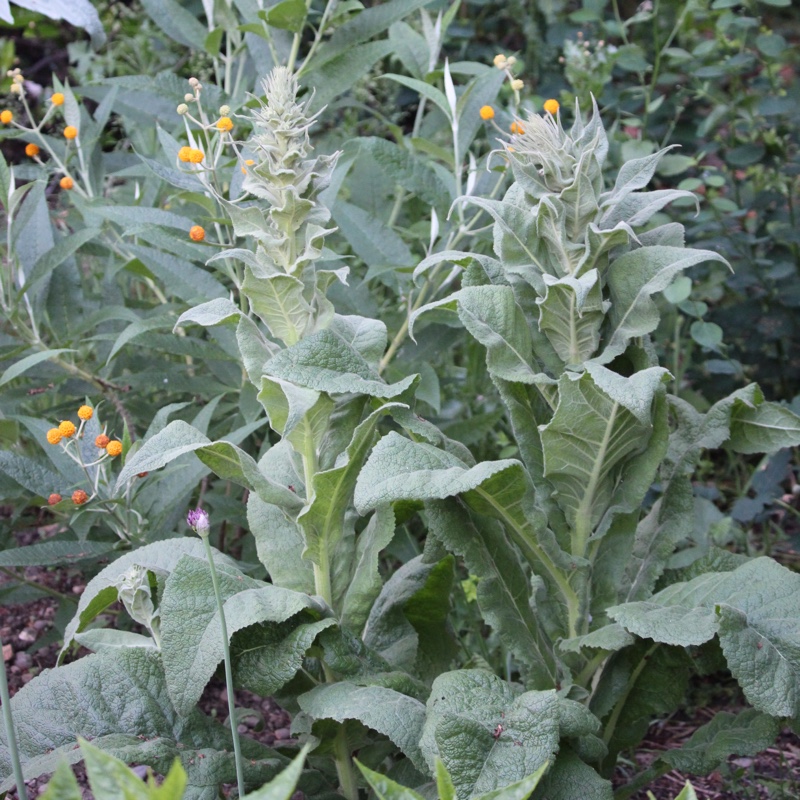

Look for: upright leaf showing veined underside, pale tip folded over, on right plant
[539,364,669,556]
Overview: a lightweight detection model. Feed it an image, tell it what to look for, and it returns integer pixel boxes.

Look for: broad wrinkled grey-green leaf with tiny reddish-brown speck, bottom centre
[420,670,559,800]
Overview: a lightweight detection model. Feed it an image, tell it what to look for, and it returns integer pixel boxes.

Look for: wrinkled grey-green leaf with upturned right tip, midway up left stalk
[266,330,417,398]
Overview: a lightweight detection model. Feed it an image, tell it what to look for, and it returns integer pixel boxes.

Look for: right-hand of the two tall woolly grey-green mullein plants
[355,106,800,798]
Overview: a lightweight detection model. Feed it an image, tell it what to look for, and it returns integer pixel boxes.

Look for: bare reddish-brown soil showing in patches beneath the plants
[0,520,800,800]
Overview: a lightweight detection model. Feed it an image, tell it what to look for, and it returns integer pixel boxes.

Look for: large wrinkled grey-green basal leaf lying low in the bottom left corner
[0,648,287,800]
